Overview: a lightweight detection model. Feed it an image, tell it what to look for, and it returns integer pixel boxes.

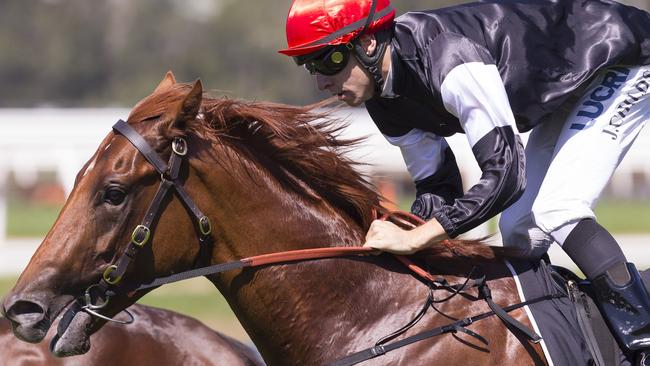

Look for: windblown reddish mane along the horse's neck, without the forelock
[202,98,380,229]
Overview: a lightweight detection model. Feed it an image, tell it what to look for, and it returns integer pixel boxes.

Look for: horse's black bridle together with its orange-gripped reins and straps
[57,120,566,366]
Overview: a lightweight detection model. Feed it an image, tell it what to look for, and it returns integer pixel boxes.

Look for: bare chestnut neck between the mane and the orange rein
[199,140,365,262]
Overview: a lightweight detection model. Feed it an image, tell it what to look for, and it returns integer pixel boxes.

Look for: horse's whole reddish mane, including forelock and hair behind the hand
[128,83,506,259]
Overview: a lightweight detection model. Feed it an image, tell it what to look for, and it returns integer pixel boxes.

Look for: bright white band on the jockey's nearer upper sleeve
[440,62,516,147]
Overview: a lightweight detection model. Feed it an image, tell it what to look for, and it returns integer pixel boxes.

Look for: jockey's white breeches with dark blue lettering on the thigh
[499,65,650,257]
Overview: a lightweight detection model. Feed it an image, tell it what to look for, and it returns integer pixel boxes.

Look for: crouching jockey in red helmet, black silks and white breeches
[280,0,650,363]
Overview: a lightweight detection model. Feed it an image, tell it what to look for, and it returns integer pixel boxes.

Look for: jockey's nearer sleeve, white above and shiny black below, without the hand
[433,62,526,237]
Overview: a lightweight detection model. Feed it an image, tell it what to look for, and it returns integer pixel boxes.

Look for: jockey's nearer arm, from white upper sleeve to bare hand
[366,38,525,254]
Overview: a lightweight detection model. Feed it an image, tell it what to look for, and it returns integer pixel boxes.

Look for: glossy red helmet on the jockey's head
[278,0,395,56]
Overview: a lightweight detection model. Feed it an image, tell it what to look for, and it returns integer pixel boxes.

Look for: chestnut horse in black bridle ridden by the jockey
[3,73,560,365]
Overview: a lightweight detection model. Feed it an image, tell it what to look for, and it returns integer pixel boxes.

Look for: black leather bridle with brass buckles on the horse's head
[59,120,213,331]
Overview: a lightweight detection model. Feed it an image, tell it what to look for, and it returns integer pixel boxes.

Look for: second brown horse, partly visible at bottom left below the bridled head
[0,304,264,366]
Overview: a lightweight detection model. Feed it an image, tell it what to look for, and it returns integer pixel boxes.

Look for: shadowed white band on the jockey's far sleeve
[384,129,442,181]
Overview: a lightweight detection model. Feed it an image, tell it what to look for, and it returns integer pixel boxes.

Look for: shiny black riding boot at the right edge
[592,263,650,357]
